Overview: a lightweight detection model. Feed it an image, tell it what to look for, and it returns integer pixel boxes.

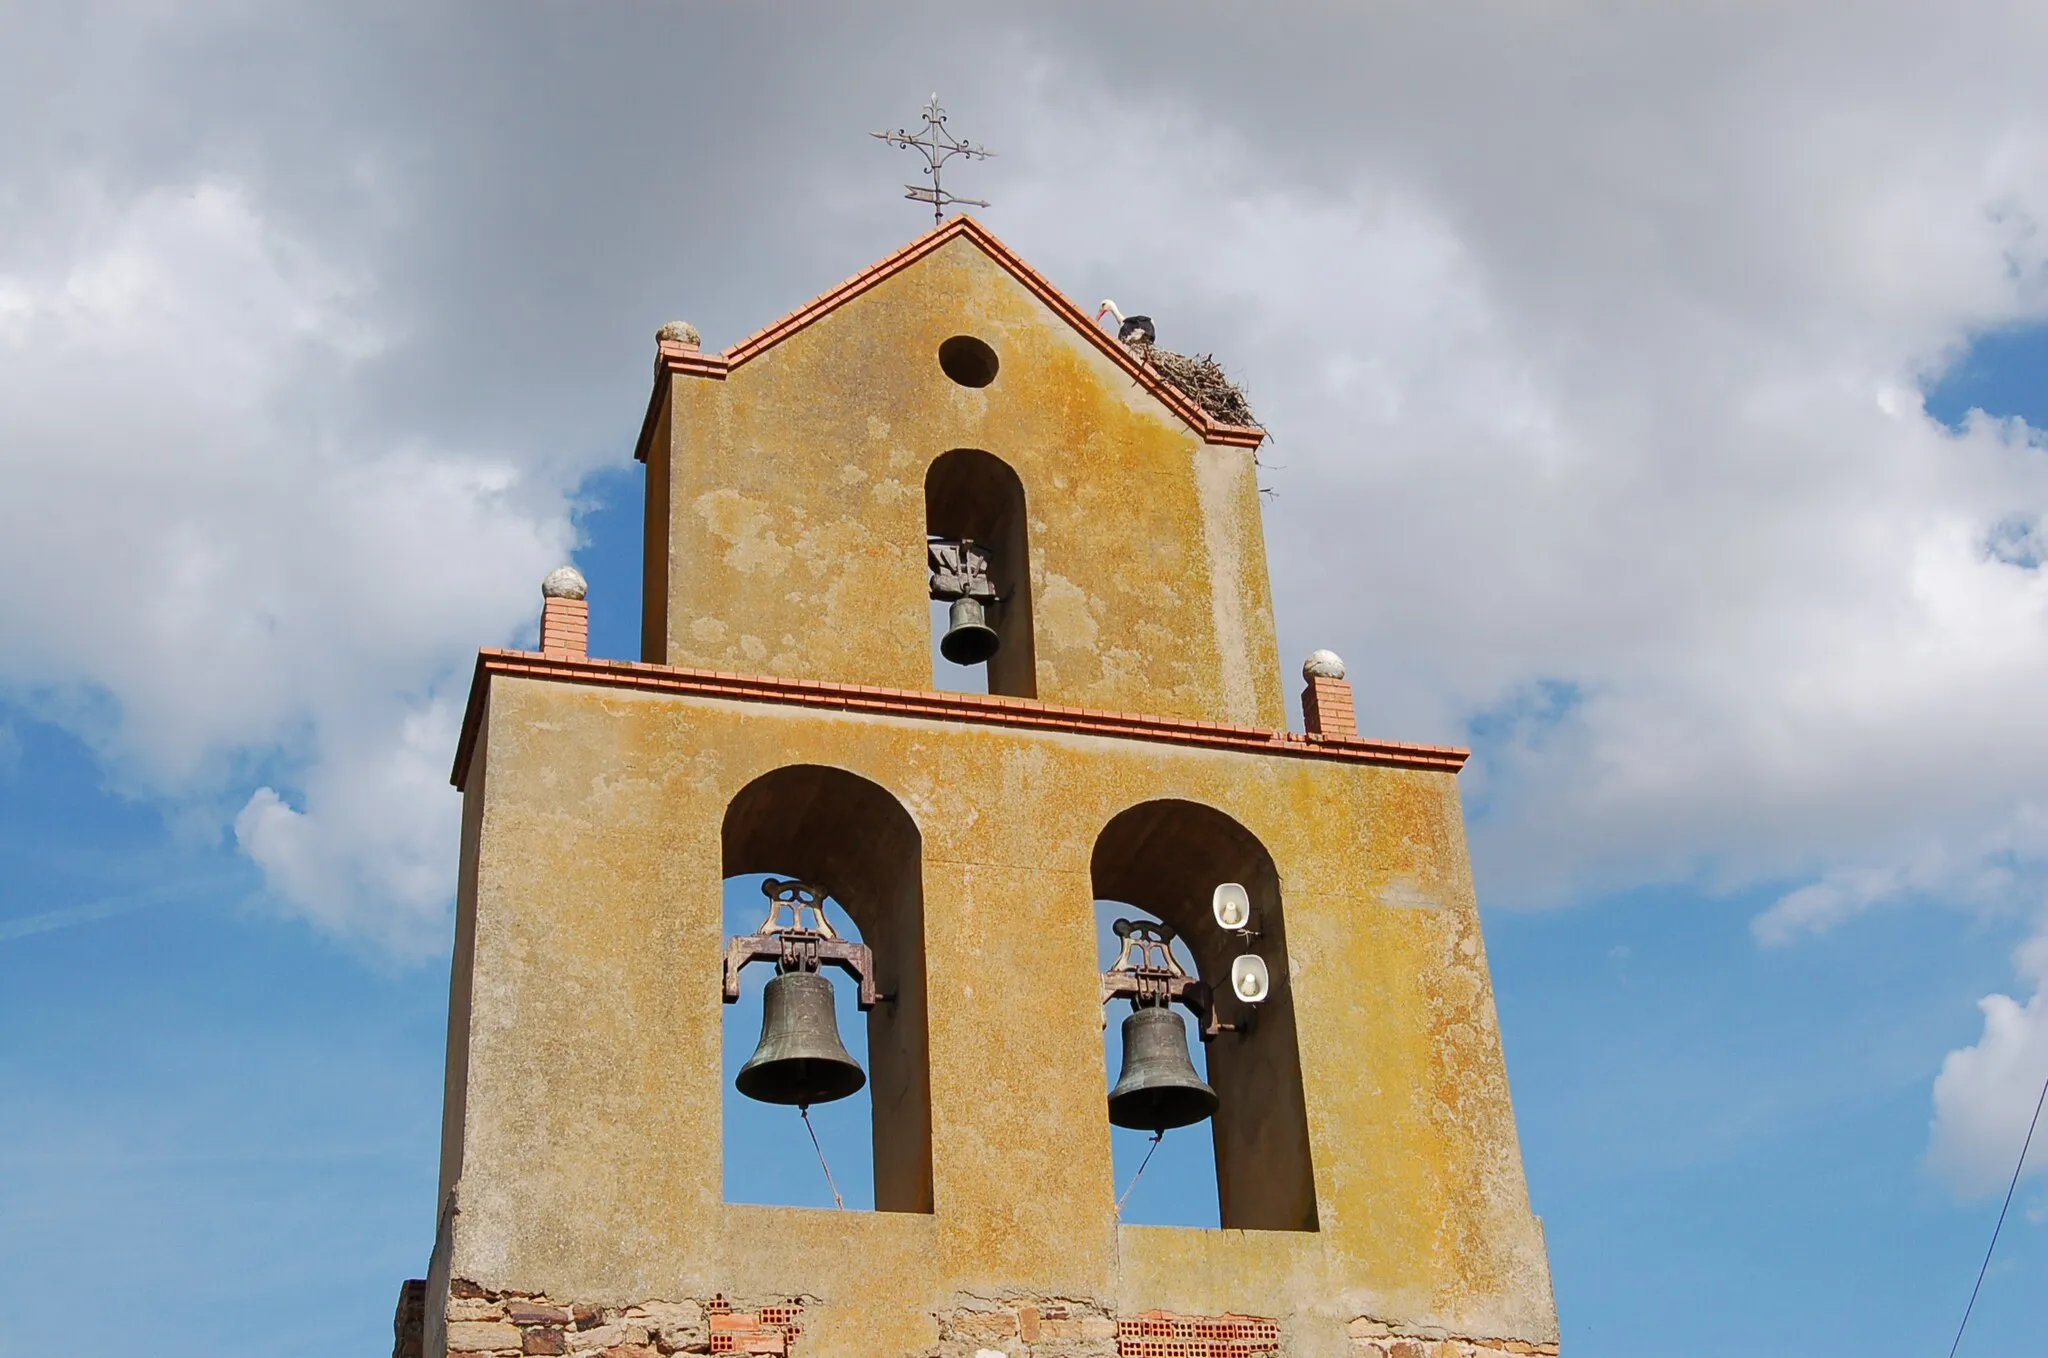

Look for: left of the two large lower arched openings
[723,764,932,1213]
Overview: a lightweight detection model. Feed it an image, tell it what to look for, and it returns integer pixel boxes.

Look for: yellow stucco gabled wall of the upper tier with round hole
[643,236,1286,727]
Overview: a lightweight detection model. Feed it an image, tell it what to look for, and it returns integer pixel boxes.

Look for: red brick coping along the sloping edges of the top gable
[633,213,1266,461]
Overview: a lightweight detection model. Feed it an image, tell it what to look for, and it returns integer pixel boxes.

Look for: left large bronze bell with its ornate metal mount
[725,877,874,1108]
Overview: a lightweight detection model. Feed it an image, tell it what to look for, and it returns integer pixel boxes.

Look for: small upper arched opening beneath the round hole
[924,449,1038,698]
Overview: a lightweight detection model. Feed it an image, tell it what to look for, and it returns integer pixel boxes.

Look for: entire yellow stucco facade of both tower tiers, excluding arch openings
[428,218,1556,1358]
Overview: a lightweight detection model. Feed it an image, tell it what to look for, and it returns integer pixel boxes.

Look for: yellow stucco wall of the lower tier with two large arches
[449,680,1556,1358]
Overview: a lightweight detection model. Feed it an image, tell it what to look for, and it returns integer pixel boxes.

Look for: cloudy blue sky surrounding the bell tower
[0,4,2048,1356]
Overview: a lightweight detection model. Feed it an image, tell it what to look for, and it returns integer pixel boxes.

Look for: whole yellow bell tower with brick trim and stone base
[399,217,1556,1358]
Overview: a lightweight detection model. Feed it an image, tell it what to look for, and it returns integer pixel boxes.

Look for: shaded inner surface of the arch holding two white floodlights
[1090,799,1317,1231]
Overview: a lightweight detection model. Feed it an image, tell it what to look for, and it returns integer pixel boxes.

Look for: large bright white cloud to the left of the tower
[0,178,569,950]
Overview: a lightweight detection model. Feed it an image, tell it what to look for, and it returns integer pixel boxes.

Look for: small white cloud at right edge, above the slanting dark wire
[1927,920,2048,1196]
